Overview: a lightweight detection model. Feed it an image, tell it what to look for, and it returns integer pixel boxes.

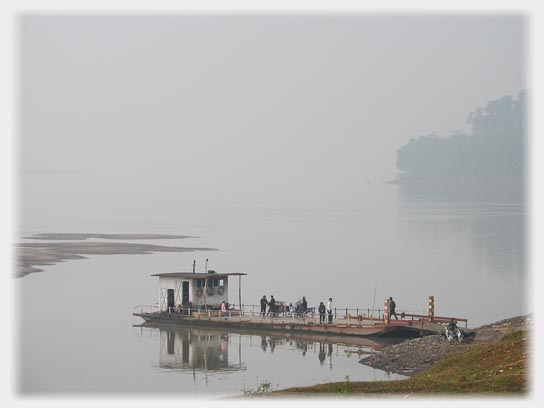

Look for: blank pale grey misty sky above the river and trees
[18,14,527,226]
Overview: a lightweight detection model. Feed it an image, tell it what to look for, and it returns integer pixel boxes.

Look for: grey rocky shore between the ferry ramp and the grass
[359,315,532,376]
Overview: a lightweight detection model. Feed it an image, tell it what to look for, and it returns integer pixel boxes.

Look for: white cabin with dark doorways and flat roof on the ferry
[152,271,246,312]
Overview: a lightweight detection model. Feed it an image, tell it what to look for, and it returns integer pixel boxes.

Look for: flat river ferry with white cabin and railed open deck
[133,264,467,338]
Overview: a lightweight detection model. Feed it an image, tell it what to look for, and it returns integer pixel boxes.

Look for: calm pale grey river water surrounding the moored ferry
[18,184,529,396]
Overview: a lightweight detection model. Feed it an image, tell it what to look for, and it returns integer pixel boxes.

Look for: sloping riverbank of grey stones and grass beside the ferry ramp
[245,316,532,397]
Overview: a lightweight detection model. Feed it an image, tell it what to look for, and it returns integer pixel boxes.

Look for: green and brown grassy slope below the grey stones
[268,330,529,397]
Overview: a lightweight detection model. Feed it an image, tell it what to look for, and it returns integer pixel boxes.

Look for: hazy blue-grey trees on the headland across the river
[395,91,527,201]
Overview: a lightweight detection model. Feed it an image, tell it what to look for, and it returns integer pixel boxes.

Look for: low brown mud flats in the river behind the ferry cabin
[15,234,216,278]
